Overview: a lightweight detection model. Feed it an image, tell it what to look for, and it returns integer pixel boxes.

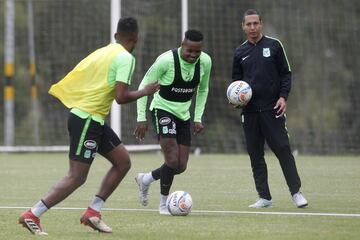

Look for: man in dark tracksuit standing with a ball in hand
[232,9,308,208]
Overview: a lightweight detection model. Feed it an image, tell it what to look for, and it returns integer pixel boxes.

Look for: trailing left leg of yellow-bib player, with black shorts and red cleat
[19,113,97,235]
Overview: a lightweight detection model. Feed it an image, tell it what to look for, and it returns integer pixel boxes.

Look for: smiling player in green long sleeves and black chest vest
[135,30,211,214]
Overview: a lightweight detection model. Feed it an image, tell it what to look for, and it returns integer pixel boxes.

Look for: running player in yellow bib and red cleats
[19,17,159,235]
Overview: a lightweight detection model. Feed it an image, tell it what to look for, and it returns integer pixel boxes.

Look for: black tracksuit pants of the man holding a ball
[242,111,301,200]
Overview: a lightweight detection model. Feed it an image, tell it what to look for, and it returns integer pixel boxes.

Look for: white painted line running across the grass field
[0,206,360,218]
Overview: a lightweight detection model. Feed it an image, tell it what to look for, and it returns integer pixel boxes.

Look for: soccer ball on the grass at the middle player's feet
[166,191,192,216]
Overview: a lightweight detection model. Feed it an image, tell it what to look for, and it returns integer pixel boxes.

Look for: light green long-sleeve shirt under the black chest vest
[137,48,211,122]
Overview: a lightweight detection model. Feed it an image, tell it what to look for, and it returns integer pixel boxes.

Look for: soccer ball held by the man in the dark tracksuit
[226,80,252,107]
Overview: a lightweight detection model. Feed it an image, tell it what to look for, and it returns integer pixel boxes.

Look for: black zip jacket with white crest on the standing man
[232,36,291,112]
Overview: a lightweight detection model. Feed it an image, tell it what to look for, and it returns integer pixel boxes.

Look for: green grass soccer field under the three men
[0,153,360,240]
